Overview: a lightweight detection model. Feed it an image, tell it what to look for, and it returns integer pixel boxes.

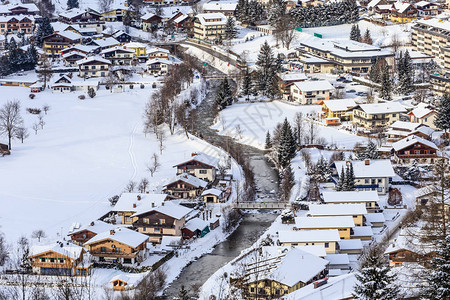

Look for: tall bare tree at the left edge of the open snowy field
[0,100,23,150]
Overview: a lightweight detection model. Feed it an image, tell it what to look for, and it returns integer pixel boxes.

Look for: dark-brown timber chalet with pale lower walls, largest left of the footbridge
[132,202,192,243]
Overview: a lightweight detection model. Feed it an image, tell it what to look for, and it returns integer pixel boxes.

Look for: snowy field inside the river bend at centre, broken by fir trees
[213,101,366,149]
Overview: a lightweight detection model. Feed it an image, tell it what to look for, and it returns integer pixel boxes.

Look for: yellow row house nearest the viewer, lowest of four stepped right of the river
[278,230,341,254]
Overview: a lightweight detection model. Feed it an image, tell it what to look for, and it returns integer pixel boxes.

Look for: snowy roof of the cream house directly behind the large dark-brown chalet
[113,193,167,212]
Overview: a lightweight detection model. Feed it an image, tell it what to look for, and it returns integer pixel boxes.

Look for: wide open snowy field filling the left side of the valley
[0,76,232,242]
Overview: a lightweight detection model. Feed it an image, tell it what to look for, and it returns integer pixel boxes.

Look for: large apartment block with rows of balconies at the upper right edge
[412,19,450,71]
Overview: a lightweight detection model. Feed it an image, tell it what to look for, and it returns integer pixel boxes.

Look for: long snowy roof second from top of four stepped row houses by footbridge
[308,203,367,217]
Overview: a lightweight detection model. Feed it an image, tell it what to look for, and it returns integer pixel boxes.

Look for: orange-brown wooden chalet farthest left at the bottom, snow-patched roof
[28,242,91,276]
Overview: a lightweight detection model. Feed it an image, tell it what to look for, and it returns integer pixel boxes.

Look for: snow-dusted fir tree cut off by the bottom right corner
[422,235,450,300]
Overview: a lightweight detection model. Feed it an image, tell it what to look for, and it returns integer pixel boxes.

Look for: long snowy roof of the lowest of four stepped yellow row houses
[278,229,341,243]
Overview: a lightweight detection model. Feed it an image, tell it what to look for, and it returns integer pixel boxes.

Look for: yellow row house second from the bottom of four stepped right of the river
[295,216,355,240]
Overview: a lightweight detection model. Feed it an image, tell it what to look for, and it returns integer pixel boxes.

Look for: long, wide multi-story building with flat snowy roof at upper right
[300,38,394,73]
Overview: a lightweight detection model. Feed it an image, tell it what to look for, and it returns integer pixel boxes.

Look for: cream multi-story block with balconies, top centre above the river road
[194,13,227,41]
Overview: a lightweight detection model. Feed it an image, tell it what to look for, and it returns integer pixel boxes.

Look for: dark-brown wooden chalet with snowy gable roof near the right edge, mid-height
[392,135,439,165]
